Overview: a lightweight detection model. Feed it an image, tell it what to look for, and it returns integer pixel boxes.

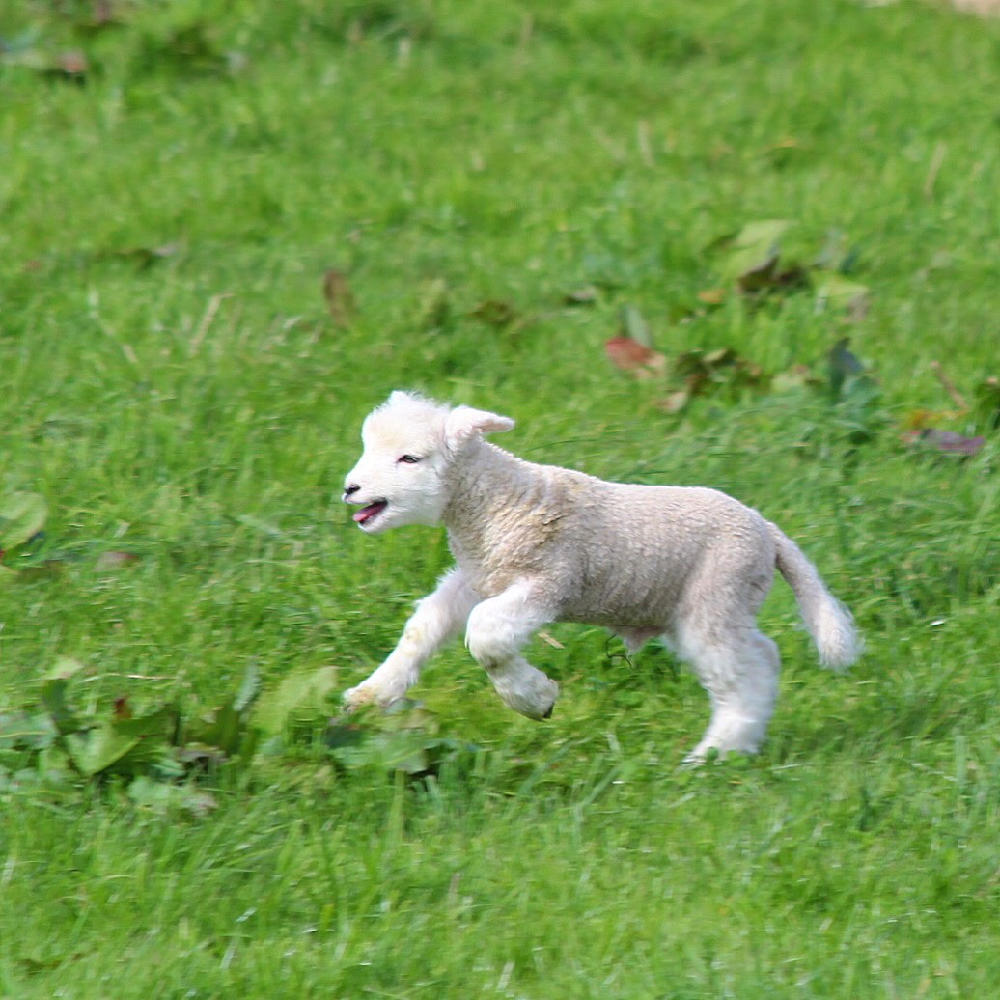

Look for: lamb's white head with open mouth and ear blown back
[344,392,514,534]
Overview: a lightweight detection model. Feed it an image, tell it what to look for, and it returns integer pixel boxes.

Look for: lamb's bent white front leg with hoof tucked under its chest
[465,581,559,719]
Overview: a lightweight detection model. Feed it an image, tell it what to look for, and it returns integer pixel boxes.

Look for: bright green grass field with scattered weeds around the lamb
[0,0,1000,1000]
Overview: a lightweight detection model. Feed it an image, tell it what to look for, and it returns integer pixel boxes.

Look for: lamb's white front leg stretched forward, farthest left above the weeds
[344,569,479,711]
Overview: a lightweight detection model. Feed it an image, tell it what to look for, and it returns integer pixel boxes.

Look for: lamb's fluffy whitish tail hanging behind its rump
[770,524,864,670]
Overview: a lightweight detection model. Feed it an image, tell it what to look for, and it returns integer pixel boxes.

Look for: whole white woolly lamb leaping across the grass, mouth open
[343,391,861,762]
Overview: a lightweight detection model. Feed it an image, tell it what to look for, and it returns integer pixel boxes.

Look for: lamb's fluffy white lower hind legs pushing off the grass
[681,626,781,763]
